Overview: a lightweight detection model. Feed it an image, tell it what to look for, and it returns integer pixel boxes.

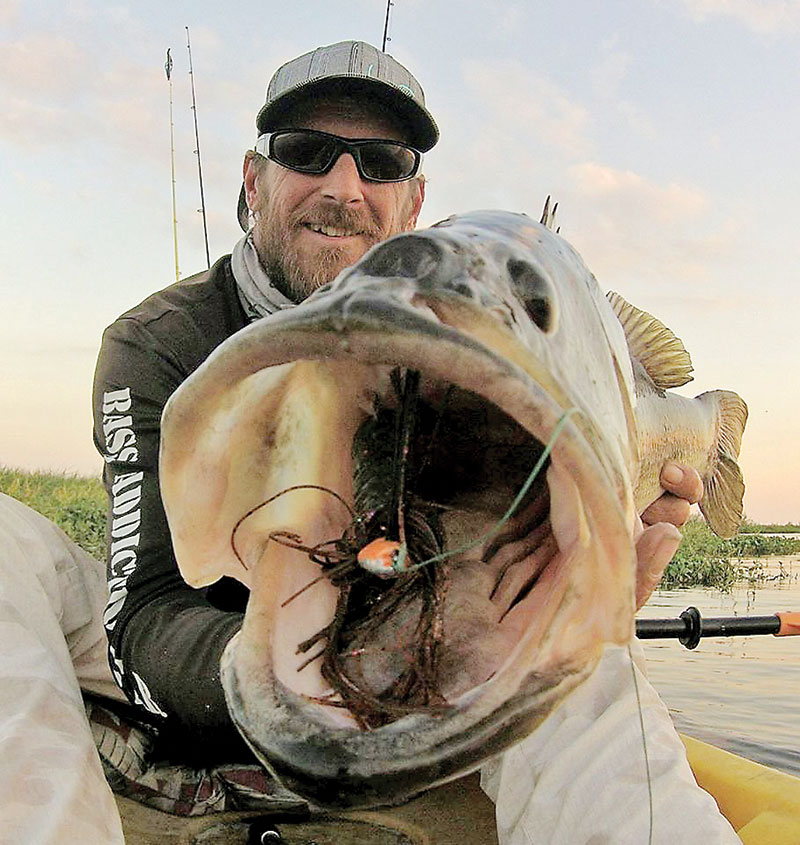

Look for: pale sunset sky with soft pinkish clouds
[0,0,800,522]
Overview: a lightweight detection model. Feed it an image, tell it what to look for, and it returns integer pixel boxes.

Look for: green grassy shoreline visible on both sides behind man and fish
[0,466,800,590]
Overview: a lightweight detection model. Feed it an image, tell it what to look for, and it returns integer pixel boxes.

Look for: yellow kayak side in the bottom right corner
[681,735,800,845]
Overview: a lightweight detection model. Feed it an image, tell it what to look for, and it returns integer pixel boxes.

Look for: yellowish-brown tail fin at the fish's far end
[697,390,747,537]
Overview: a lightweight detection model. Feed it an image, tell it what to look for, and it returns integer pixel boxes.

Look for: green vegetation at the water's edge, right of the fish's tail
[660,516,800,590]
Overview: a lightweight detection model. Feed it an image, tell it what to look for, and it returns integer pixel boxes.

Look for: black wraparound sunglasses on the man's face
[256,129,422,182]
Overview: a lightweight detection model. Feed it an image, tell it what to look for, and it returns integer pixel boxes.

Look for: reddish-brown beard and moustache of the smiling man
[253,203,384,302]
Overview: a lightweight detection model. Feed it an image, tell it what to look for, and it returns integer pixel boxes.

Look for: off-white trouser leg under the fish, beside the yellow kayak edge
[481,641,741,845]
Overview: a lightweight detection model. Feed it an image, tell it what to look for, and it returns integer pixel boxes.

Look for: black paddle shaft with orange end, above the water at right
[636,607,800,649]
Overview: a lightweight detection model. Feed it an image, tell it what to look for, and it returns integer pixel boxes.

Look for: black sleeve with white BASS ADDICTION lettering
[93,318,244,763]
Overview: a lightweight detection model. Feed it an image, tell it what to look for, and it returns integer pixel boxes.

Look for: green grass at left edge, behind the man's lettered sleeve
[0,467,106,560]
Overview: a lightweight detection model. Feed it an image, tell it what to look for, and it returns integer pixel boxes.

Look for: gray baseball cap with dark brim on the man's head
[237,41,439,231]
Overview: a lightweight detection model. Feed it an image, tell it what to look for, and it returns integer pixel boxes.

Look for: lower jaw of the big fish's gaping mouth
[222,432,632,808]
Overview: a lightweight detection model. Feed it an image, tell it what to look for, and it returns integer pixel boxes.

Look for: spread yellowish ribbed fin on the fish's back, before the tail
[606,291,694,390]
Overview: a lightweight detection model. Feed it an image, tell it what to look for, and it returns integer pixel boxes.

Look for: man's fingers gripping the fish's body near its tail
[636,463,703,610]
